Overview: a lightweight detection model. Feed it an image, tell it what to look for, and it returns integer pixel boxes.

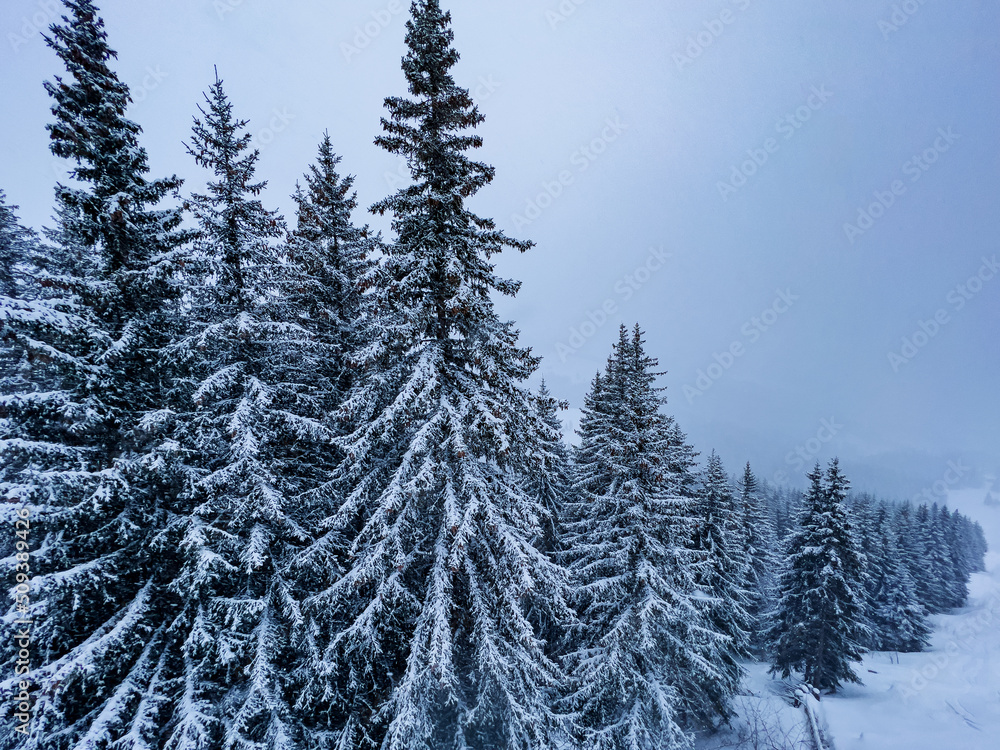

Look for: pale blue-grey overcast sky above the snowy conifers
[0,0,1000,506]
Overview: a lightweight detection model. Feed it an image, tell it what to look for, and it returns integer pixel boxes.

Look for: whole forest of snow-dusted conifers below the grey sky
[0,0,1000,750]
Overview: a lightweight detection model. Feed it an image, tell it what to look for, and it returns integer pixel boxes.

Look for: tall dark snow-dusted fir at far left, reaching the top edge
[0,0,186,748]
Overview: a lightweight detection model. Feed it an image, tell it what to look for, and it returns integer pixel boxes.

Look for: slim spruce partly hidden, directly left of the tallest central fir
[282,134,380,748]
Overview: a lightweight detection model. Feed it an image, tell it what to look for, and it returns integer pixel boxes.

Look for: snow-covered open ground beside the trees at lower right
[699,487,1000,750]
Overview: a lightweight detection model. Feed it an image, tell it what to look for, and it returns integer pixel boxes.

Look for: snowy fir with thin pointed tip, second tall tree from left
[162,78,322,750]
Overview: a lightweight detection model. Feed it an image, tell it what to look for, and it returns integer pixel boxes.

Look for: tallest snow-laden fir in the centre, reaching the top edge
[302,0,566,750]
